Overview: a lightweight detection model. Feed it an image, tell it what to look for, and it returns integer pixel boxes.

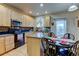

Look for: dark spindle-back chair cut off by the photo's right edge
[69,41,79,56]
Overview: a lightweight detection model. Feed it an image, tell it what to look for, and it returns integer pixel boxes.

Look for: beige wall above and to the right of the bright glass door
[52,10,79,40]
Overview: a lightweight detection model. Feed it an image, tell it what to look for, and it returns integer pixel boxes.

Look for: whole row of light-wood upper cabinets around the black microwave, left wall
[0,5,34,27]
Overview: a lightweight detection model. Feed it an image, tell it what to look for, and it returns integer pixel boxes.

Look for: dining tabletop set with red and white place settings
[44,36,76,47]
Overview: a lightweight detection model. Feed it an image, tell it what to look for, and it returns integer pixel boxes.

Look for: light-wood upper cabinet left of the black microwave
[0,5,10,26]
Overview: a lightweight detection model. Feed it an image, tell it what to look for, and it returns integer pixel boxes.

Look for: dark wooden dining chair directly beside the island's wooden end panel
[41,39,56,56]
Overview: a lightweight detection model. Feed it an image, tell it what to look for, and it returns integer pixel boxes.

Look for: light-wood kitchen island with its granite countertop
[25,32,47,56]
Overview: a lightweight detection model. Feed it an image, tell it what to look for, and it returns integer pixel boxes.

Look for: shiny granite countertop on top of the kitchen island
[25,32,47,39]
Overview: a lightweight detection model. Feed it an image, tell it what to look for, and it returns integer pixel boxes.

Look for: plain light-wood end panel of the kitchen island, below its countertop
[27,37,41,56]
